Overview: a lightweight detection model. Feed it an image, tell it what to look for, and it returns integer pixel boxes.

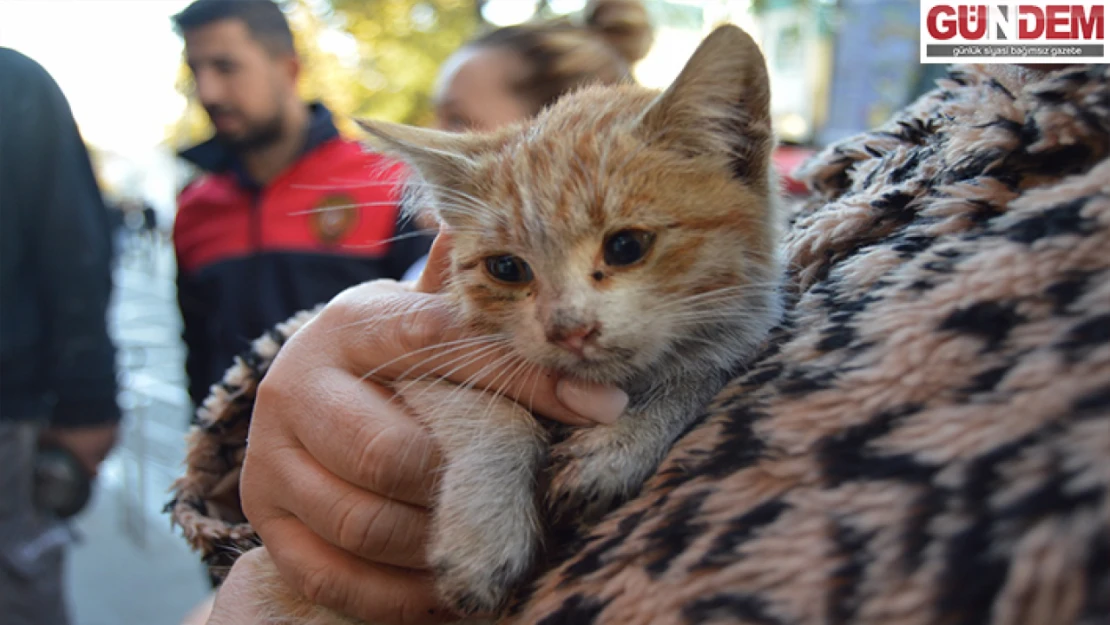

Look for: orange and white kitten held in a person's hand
[253,26,780,624]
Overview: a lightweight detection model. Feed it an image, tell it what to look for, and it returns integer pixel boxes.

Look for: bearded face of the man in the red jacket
[184,20,296,150]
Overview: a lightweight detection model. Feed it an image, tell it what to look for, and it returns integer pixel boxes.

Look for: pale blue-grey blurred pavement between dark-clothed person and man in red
[67,235,209,625]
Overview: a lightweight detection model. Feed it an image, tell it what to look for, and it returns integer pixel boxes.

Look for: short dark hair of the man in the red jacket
[173,0,295,54]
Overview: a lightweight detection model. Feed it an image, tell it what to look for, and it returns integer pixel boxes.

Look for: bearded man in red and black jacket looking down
[173,0,431,415]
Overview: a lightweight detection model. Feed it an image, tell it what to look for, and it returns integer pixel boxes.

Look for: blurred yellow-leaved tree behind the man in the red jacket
[167,0,480,149]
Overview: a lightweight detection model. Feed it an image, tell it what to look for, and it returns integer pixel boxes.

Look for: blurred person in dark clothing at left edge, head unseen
[0,48,120,625]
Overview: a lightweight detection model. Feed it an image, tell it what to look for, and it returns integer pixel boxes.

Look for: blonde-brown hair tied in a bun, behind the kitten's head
[467,0,654,113]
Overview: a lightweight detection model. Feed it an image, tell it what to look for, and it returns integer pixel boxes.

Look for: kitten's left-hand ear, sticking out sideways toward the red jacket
[355,120,490,225]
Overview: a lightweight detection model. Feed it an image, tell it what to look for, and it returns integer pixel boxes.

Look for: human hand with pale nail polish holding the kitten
[241,236,627,624]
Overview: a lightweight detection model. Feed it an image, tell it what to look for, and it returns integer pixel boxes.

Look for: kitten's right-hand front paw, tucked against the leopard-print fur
[547,427,657,523]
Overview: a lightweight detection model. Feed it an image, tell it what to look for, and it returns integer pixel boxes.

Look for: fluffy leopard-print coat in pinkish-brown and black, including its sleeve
[170,65,1110,625]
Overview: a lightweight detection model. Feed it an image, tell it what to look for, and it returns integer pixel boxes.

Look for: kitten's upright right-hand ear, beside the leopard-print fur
[640,24,774,184]
